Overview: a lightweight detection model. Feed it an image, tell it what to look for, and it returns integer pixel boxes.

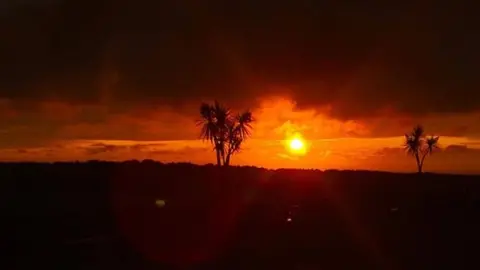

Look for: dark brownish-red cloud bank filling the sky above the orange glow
[0,0,480,118]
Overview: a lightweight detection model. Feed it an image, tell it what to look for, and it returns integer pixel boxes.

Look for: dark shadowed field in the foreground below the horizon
[0,162,480,270]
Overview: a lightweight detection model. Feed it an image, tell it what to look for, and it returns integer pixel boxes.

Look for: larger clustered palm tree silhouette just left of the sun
[197,101,253,166]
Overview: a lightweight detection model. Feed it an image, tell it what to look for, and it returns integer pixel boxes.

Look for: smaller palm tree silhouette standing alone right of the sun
[404,125,440,173]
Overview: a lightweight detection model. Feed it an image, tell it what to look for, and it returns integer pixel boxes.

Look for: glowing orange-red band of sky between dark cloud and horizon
[0,97,480,173]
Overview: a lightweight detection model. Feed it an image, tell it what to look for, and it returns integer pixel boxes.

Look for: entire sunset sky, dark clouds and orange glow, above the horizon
[0,0,480,173]
